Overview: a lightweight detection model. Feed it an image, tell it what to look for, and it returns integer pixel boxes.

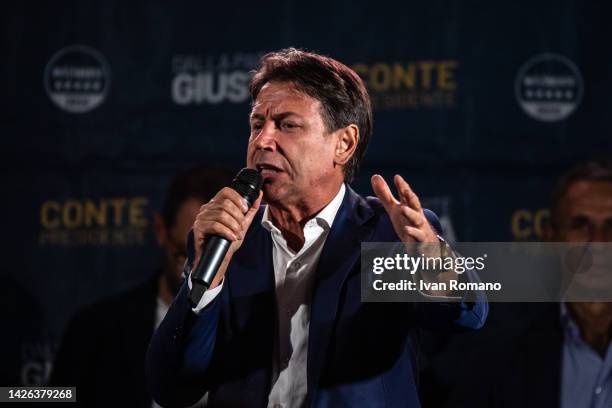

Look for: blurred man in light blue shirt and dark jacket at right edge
[491,161,612,408]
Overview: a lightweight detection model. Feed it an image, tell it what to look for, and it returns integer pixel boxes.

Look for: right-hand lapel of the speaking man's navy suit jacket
[307,186,374,398]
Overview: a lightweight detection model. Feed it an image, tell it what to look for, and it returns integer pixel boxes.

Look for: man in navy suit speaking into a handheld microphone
[147,49,487,407]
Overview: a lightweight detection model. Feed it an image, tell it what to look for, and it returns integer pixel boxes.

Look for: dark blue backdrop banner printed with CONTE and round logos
[0,0,612,385]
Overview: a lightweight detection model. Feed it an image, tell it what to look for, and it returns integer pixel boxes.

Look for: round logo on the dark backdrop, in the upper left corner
[44,45,110,113]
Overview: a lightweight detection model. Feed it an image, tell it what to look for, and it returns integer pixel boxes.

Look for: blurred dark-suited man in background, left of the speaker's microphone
[50,167,231,408]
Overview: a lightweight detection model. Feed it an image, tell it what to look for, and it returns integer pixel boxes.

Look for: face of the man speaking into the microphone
[247,82,342,205]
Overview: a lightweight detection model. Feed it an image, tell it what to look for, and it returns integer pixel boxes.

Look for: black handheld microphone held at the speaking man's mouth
[189,168,263,307]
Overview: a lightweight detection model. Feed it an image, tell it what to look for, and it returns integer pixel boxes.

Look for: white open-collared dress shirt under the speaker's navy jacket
[188,184,346,407]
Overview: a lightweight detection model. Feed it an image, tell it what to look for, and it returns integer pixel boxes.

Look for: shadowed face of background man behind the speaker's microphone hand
[160,198,203,294]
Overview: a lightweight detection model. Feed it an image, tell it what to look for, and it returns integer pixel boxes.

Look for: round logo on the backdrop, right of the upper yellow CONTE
[515,53,583,122]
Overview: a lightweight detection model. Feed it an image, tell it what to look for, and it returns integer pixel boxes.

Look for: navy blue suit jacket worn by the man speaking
[146,188,487,407]
